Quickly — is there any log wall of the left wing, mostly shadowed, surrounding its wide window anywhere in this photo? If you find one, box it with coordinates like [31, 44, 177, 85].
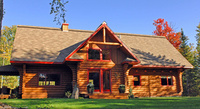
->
[16, 65, 72, 99]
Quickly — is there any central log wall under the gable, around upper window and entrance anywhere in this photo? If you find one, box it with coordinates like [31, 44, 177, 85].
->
[77, 44, 126, 94]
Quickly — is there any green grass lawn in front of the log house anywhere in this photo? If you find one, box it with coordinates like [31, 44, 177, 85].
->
[0, 97, 200, 109]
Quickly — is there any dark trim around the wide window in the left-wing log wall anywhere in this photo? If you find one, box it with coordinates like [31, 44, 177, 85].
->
[37, 72, 62, 87]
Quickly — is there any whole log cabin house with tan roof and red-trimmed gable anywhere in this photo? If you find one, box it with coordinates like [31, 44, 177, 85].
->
[4, 22, 193, 99]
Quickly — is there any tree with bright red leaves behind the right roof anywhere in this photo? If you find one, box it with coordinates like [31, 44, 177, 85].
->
[153, 18, 181, 49]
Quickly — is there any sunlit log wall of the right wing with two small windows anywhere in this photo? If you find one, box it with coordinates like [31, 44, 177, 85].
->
[128, 69, 181, 97]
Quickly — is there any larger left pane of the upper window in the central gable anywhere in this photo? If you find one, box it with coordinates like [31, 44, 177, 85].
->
[88, 49, 100, 60]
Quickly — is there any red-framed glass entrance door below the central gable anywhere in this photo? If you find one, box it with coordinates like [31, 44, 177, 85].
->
[88, 69, 111, 93]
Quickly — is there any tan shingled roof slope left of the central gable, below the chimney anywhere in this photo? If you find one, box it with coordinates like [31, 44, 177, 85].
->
[11, 25, 93, 63]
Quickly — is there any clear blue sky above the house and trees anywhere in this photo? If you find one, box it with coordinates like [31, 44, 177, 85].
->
[3, 0, 200, 44]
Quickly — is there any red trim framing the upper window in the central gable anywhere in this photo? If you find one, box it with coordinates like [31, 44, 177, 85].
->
[87, 47, 111, 62]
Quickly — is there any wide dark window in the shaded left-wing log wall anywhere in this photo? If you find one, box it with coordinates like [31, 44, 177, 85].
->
[39, 73, 60, 86]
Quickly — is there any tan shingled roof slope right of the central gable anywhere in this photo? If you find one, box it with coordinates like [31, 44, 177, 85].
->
[117, 33, 193, 68]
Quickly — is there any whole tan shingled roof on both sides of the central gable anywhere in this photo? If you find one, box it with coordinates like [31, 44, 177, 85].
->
[11, 25, 193, 68]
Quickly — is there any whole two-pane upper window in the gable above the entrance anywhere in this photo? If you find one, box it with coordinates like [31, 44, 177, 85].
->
[88, 49, 110, 60]
